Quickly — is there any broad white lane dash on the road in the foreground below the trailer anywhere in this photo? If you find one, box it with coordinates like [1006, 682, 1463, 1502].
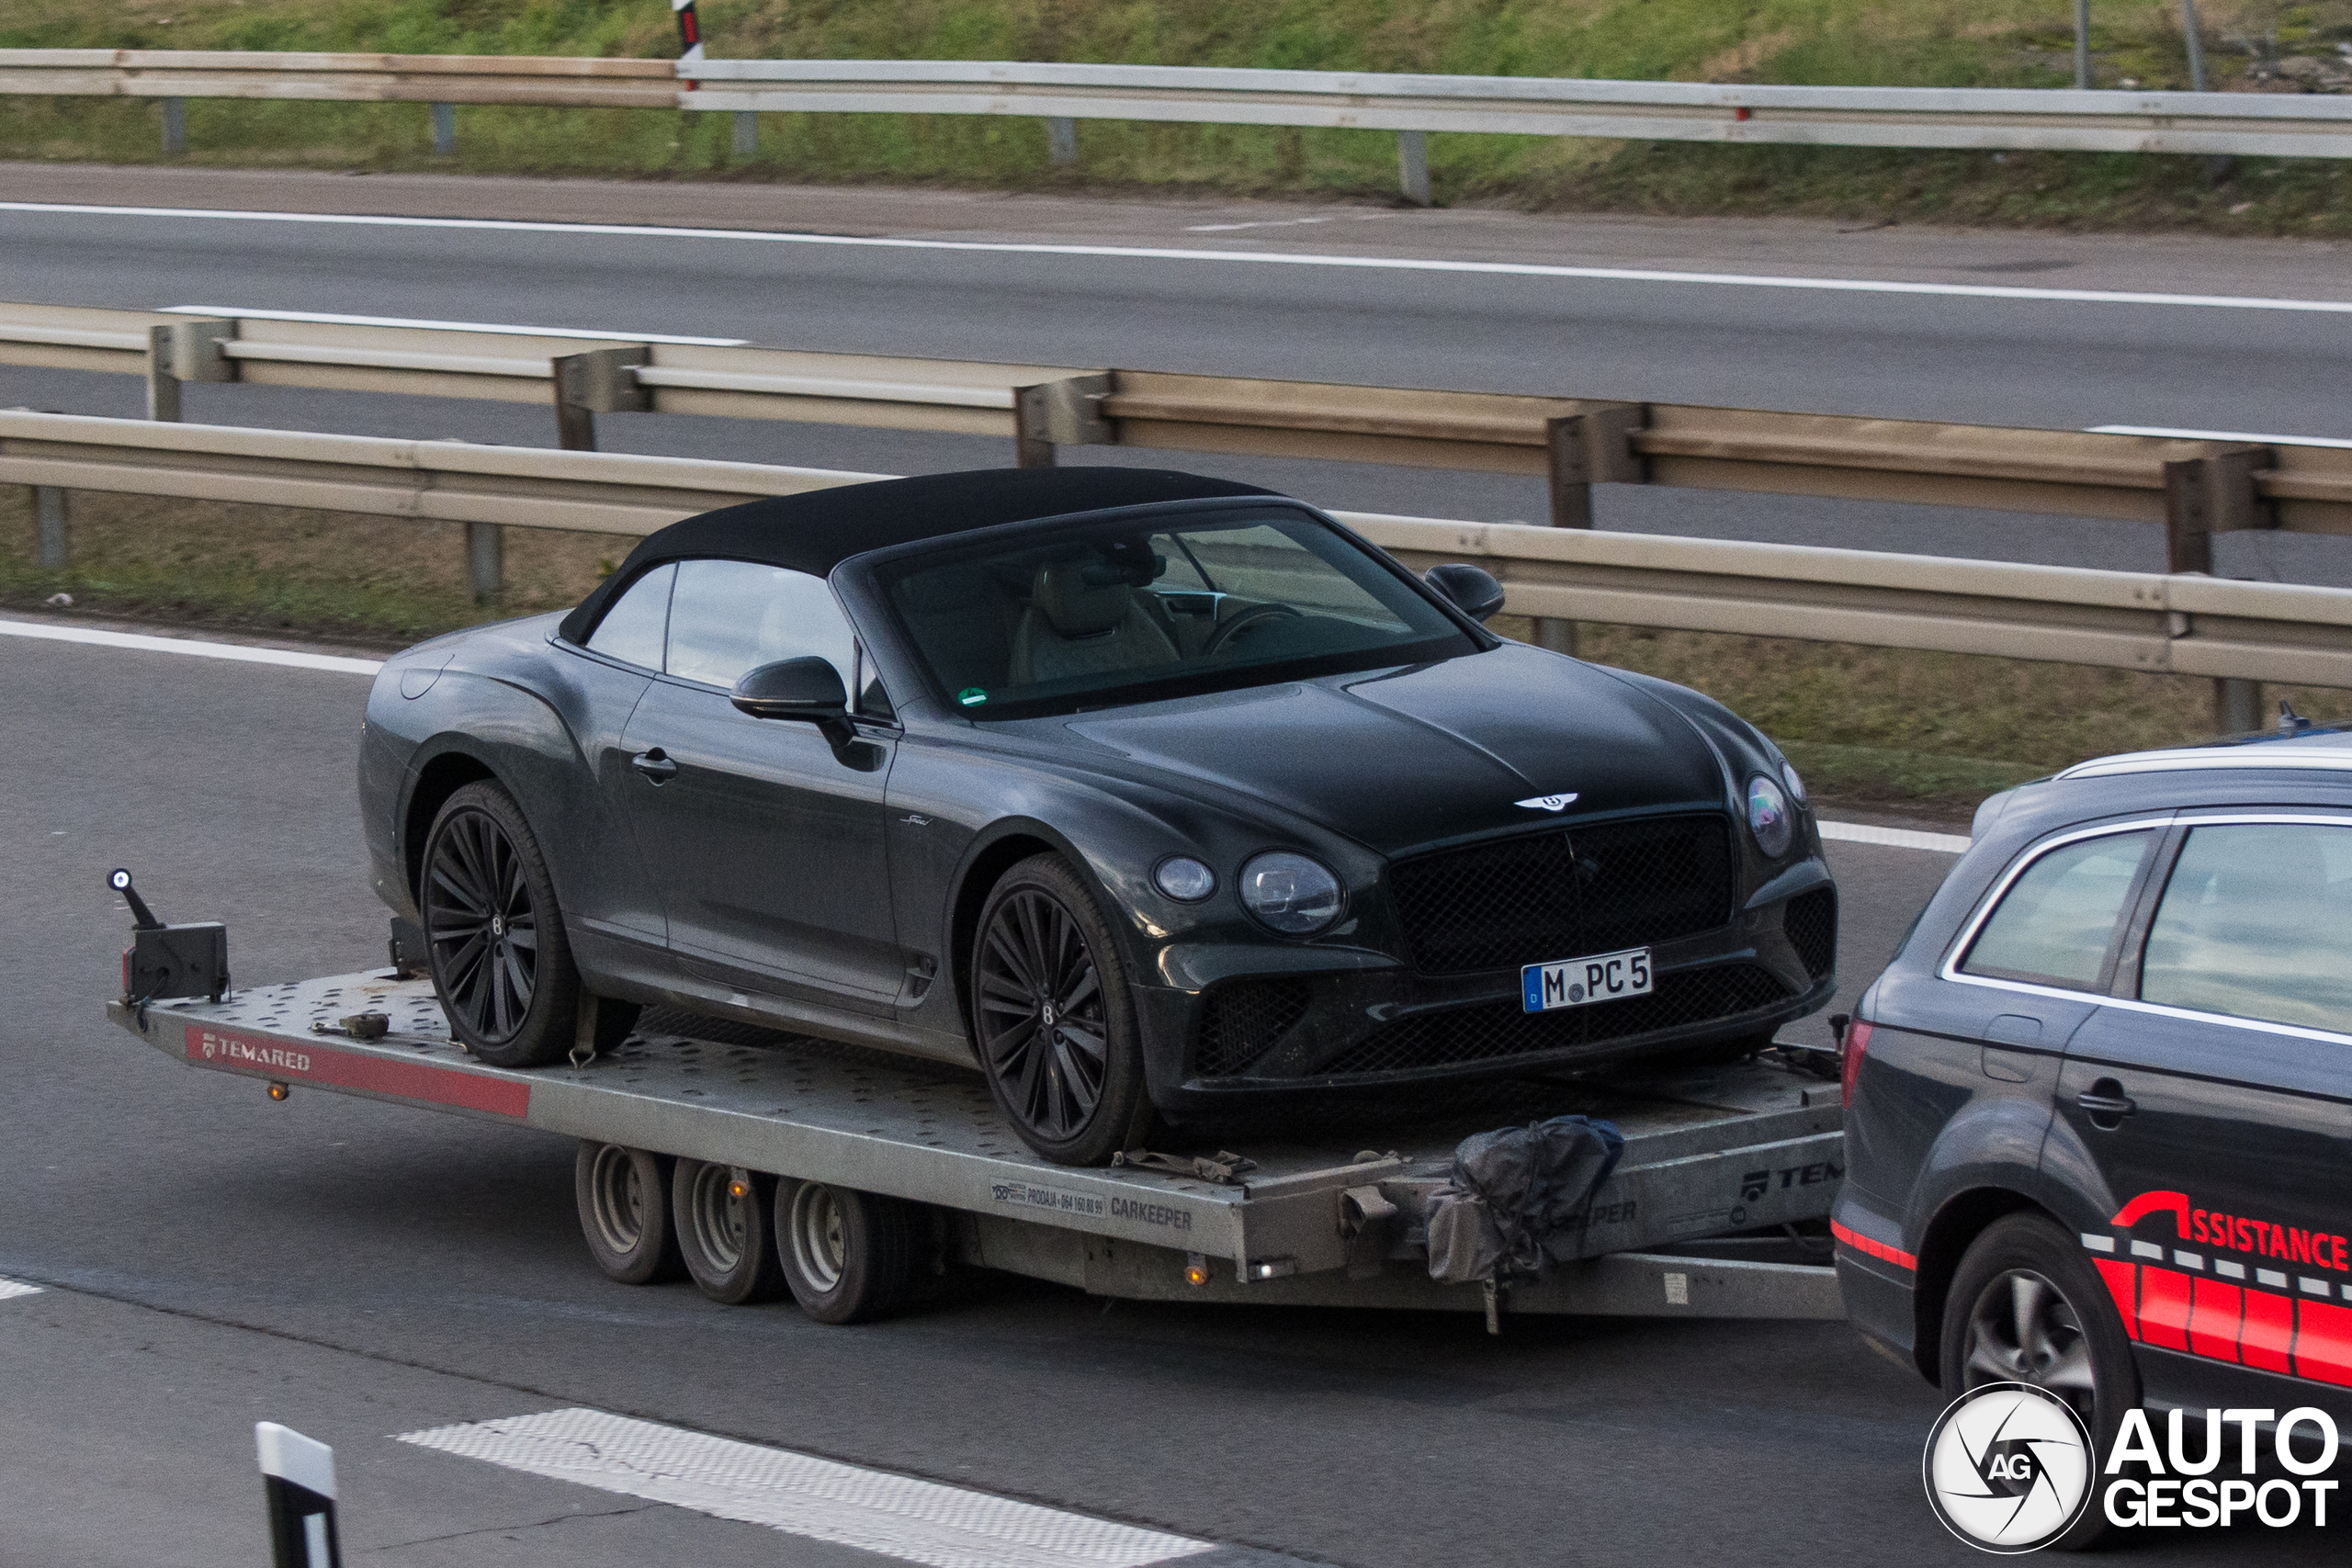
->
[398, 1411, 1214, 1568]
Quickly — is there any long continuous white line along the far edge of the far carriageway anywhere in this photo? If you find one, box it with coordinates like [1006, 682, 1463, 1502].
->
[0, 202, 2352, 315]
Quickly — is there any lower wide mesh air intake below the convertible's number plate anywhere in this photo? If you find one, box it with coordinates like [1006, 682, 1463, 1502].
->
[1317, 964, 1788, 1075]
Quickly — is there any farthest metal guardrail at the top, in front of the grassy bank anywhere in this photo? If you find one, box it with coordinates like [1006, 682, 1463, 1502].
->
[14, 50, 2352, 205]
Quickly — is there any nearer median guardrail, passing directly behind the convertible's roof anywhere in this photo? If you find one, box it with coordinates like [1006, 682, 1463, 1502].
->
[14, 412, 2352, 686]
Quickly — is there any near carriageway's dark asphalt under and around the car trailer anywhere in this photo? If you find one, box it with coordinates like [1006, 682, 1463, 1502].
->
[0, 639, 2338, 1568]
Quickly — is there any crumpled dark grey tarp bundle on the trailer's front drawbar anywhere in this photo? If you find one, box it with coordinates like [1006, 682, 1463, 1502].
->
[1425, 1117, 1625, 1283]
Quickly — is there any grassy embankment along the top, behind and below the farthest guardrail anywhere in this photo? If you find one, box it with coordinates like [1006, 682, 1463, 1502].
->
[0, 0, 2352, 235]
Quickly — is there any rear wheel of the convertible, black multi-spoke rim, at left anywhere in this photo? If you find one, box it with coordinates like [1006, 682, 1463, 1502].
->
[416, 781, 581, 1067]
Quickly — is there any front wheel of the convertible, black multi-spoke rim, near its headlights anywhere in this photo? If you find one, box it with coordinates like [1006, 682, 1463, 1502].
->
[971, 853, 1155, 1166]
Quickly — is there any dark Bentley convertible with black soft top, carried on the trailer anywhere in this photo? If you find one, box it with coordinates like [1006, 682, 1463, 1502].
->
[360, 468, 1837, 1164]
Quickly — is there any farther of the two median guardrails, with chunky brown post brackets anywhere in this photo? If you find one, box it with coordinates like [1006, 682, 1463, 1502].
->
[0, 303, 2352, 571]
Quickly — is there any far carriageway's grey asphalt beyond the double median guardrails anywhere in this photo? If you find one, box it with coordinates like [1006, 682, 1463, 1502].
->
[14, 164, 2352, 583]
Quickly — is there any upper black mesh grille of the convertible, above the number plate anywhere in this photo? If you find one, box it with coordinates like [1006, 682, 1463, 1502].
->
[1387, 813, 1731, 976]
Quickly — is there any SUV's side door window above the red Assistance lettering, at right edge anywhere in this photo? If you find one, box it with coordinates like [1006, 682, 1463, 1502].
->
[2141, 823, 2352, 1034]
